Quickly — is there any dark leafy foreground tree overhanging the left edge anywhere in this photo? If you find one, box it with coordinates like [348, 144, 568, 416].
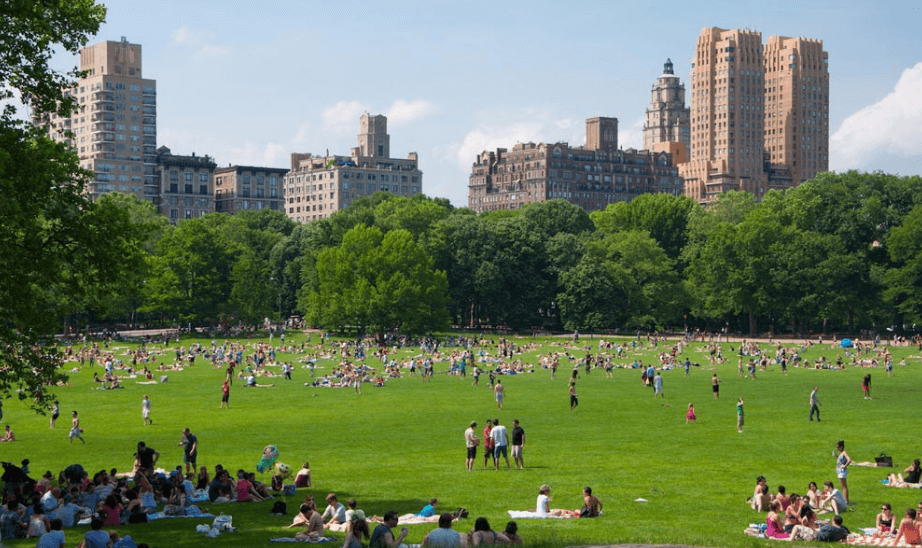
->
[0, 0, 130, 410]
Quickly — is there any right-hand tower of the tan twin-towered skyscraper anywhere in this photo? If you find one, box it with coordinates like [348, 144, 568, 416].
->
[764, 36, 829, 187]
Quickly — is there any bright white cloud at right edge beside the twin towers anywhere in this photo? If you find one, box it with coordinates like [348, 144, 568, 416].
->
[829, 63, 922, 171]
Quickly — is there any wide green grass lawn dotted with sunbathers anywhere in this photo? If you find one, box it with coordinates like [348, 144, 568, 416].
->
[0, 334, 922, 548]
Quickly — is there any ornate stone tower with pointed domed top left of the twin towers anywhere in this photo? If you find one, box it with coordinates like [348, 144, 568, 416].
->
[643, 59, 691, 164]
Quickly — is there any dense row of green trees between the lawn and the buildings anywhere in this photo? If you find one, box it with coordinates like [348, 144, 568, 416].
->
[94, 172, 922, 340]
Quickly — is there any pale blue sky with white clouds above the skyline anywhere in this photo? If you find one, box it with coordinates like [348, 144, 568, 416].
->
[41, 0, 922, 207]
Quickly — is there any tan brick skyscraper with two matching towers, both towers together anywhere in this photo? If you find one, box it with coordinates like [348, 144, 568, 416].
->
[679, 27, 829, 204]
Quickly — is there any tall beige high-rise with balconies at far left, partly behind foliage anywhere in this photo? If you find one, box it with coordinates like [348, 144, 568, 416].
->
[40, 38, 160, 202]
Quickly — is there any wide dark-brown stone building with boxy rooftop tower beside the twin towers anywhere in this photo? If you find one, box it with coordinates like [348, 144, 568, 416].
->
[468, 117, 683, 213]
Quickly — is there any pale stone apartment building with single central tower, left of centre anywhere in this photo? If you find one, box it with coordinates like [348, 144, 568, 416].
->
[284, 114, 423, 223]
